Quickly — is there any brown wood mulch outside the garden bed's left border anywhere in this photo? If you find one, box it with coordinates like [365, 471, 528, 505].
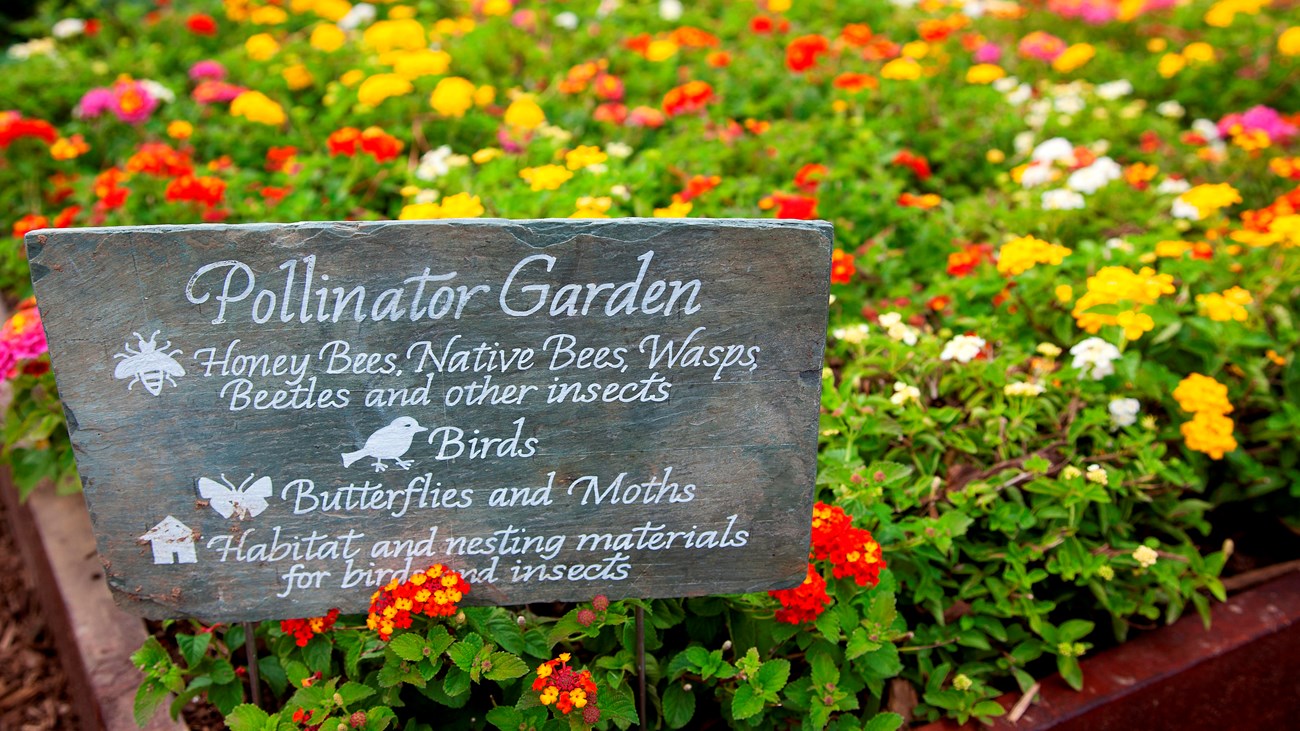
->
[0, 491, 79, 731]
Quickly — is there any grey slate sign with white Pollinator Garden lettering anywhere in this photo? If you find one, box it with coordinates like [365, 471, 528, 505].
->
[27, 219, 832, 622]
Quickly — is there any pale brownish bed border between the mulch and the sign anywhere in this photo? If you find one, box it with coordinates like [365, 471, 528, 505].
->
[0, 468, 189, 731]
